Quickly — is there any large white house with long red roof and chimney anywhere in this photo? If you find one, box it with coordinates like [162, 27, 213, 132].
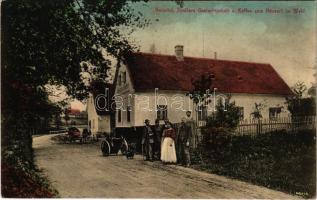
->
[114, 45, 292, 128]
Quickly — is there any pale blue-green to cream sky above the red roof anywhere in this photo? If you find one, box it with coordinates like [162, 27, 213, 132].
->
[72, 1, 317, 109]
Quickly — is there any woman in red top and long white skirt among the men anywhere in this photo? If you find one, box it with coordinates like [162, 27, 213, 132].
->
[161, 123, 177, 163]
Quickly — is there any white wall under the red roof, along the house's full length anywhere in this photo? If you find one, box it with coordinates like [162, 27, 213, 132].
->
[116, 91, 289, 127]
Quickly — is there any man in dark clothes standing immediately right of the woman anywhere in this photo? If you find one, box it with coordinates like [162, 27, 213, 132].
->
[176, 118, 192, 167]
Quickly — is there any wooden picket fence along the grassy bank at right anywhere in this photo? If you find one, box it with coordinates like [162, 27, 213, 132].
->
[234, 116, 316, 135]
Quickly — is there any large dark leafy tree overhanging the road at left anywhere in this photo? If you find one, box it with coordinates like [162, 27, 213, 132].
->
[1, 0, 148, 162]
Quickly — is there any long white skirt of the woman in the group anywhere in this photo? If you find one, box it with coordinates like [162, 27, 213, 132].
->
[161, 137, 177, 163]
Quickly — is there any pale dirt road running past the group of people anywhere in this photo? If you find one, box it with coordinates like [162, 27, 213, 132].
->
[33, 135, 297, 199]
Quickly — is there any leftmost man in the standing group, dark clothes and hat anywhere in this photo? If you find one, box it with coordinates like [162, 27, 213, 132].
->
[142, 119, 154, 161]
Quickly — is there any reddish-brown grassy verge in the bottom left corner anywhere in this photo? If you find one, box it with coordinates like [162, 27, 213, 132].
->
[1, 145, 59, 198]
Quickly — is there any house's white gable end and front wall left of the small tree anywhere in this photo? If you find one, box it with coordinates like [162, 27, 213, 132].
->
[115, 61, 193, 127]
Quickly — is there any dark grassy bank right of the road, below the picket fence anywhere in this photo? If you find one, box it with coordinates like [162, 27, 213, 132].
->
[193, 130, 316, 198]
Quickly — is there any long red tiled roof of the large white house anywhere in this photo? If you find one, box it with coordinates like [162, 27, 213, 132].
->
[126, 53, 292, 95]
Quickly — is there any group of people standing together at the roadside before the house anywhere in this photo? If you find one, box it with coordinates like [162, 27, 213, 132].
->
[142, 111, 192, 166]
